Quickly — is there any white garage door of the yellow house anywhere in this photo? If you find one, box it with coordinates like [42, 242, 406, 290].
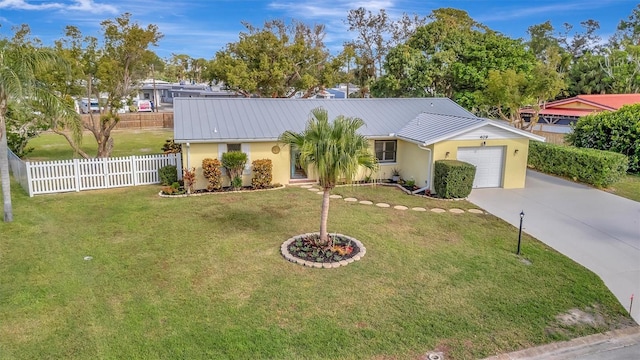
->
[458, 146, 504, 188]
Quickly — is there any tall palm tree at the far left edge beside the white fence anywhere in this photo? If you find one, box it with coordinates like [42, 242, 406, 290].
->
[0, 38, 72, 222]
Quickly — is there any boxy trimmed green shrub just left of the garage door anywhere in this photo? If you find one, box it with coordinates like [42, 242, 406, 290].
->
[433, 160, 476, 199]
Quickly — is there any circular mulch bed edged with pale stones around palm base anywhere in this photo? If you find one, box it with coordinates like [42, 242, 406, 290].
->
[280, 233, 367, 269]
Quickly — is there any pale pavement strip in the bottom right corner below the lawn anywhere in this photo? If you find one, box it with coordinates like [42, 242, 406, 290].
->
[485, 326, 640, 360]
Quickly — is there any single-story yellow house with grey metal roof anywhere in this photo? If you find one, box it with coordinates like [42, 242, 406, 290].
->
[174, 98, 544, 189]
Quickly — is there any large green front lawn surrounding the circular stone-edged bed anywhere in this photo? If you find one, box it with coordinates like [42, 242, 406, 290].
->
[0, 183, 630, 359]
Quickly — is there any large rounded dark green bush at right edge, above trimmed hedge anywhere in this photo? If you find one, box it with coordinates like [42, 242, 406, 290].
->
[566, 104, 640, 173]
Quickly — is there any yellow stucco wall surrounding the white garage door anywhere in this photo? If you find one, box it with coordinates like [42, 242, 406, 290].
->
[433, 138, 529, 189]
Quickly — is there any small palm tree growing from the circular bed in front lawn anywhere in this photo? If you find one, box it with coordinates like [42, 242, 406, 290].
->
[280, 108, 378, 244]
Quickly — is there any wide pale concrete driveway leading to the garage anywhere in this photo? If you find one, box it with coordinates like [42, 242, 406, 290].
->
[469, 170, 640, 323]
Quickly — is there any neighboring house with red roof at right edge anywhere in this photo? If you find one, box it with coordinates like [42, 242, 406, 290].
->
[520, 94, 640, 133]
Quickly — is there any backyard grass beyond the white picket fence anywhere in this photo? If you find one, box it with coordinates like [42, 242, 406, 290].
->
[27, 129, 173, 161]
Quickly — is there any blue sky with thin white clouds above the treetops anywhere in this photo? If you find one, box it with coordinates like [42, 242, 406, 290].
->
[0, 0, 638, 59]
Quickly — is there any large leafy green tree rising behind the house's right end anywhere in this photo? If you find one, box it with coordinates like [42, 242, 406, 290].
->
[372, 8, 535, 110]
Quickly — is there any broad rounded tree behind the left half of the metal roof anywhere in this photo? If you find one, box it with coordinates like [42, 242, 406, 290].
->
[210, 20, 339, 97]
